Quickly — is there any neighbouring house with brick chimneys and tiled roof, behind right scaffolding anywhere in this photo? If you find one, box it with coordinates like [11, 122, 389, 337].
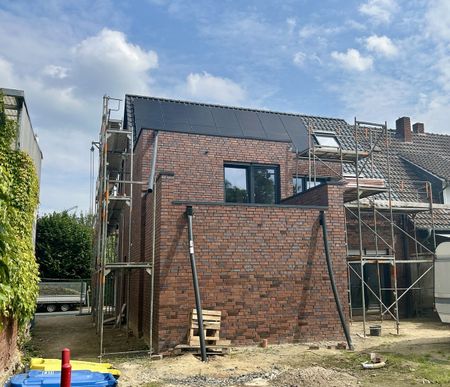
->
[314, 117, 450, 322]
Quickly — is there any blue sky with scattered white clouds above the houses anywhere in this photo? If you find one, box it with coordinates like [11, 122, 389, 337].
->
[0, 0, 450, 214]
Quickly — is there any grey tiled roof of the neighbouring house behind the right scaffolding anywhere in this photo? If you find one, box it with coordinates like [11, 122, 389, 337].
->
[330, 125, 450, 230]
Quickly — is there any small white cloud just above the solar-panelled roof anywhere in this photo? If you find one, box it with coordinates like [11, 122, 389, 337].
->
[181, 72, 246, 104]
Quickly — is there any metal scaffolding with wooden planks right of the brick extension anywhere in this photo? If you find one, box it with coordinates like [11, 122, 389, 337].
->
[298, 118, 436, 336]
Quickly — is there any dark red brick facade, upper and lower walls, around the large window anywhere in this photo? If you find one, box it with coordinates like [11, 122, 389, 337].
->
[124, 130, 348, 351]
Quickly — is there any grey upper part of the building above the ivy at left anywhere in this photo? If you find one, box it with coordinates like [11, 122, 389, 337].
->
[0, 88, 42, 181]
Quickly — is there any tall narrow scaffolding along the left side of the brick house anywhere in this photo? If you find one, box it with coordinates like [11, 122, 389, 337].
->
[91, 96, 153, 359]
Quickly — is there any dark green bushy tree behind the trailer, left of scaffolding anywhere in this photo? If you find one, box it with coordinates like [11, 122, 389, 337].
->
[36, 211, 93, 279]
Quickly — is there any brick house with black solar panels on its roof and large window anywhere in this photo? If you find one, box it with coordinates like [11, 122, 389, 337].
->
[121, 96, 356, 351]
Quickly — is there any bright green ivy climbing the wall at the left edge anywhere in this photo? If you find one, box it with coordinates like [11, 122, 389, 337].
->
[0, 94, 39, 326]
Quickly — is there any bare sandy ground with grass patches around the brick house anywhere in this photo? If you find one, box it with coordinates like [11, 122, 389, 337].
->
[31, 316, 450, 387]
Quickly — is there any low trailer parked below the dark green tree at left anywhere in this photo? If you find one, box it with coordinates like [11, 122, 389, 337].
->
[37, 281, 87, 313]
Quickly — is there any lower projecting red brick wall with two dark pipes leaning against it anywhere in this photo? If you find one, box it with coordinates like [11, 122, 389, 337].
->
[144, 177, 347, 350]
